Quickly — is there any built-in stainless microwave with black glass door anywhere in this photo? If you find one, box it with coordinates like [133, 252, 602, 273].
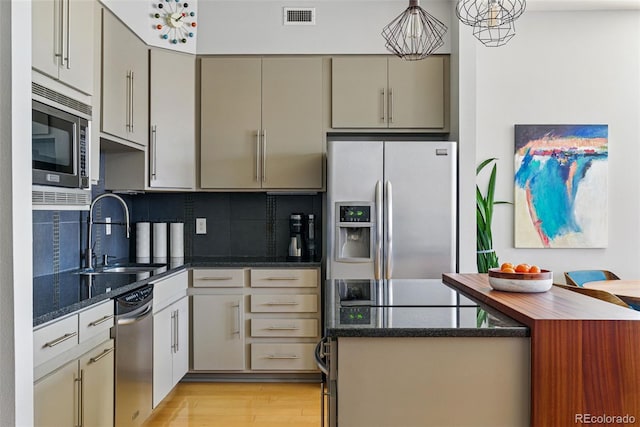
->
[31, 100, 90, 189]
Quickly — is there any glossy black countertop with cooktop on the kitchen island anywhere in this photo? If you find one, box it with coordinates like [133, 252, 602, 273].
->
[324, 279, 530, 338]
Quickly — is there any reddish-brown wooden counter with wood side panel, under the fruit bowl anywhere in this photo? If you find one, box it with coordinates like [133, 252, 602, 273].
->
[442, 273, 640, 427]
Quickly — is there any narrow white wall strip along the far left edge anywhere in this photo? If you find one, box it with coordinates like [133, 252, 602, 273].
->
[0, 0, 33, 426]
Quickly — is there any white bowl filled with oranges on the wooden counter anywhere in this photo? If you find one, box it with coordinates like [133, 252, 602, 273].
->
[489, 262, 553, 292]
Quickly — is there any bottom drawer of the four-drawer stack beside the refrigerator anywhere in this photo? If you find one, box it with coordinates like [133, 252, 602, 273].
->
[251, 343, 317, 371]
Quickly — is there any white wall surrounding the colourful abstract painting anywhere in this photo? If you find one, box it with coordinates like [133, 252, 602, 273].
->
[468, 11, 640, 281]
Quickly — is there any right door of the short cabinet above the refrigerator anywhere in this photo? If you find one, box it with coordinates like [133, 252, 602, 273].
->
[388, 56, 445, 128]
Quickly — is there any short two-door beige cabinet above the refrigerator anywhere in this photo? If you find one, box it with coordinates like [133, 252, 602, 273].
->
[331, 56, 449, 131]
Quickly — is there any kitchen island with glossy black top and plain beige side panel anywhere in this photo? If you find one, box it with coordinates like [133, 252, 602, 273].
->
[318, 279, 530, 427]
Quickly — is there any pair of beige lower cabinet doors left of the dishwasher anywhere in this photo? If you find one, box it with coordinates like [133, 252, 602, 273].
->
[34, 340, 114, 427]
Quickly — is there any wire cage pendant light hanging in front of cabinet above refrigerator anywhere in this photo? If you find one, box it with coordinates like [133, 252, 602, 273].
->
[382, 0, 447, 61]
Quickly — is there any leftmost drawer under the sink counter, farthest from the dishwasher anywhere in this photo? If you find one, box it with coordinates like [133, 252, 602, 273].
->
[33, 314, 78, 366]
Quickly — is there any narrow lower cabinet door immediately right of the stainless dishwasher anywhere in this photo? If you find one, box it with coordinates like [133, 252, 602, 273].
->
[153, 306, 175, 408]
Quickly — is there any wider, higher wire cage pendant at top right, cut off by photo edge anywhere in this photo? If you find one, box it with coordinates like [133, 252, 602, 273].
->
[456, 0, 527, 27]
